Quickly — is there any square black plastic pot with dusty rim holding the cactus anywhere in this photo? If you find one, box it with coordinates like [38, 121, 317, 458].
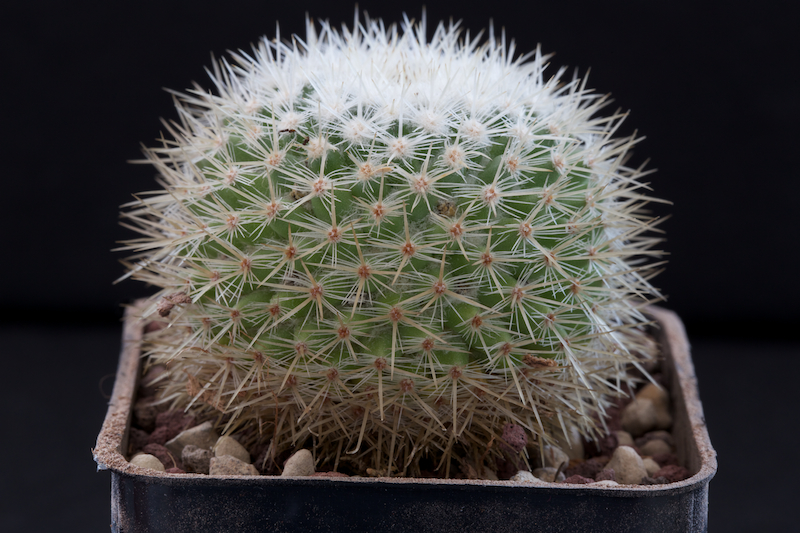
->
[94, 308, 717, 533]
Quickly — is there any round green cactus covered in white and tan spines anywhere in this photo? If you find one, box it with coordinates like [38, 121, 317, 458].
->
[123, 14, 660, 475]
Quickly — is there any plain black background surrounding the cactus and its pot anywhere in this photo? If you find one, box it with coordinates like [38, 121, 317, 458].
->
[0, 0, 800, 532]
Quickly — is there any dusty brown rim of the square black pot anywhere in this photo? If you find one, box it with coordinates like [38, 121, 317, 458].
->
[92, 301, 717, 497]
